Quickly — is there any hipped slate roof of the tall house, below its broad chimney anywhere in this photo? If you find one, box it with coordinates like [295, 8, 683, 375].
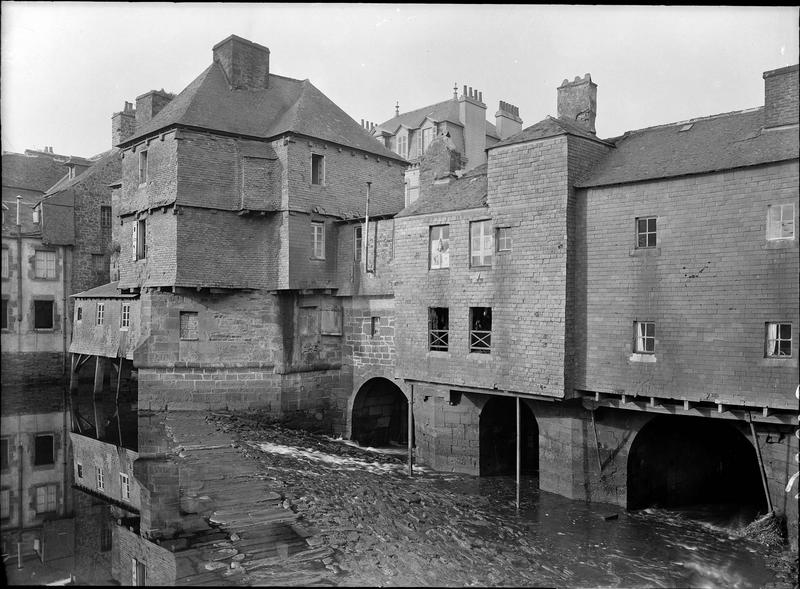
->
[120, 63, 401, 160]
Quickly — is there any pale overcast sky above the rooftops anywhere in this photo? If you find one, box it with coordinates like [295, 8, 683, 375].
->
[0, 2, 799, 157]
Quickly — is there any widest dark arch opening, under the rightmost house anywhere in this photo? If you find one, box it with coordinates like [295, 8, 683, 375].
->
[627, 415, 766, 512]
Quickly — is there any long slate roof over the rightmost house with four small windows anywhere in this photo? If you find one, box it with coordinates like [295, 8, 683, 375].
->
[577, 108, 798, 187]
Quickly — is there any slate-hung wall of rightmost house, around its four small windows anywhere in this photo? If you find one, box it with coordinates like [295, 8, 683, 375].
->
[575, 162, 800, 409]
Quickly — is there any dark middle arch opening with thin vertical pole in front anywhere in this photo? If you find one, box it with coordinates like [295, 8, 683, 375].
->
[479, 396, 539, 476]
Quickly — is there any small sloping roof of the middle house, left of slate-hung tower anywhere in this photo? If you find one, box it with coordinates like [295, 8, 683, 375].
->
[397, 164, 488, 217]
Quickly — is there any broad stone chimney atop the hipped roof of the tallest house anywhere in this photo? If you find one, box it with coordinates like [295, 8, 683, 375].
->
[213, 35, 269, 90]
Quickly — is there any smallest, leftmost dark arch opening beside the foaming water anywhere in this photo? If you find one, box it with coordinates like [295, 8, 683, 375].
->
[348, 376, 413, 446]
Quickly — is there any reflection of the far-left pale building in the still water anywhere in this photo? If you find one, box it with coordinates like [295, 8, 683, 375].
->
[0, 386, 72, 562]
